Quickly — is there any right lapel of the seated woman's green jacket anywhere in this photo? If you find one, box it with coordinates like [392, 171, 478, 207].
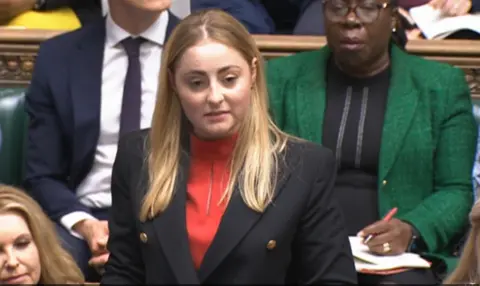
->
[378, 45, 418, 185]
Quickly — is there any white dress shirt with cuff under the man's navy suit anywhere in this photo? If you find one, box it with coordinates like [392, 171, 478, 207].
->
[60, 11, 169, 238]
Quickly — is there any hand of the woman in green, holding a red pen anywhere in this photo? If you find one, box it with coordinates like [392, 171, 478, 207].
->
[358, 218, 413, 255]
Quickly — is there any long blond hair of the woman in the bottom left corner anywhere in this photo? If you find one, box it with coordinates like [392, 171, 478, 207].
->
[0, 185, 84, 284]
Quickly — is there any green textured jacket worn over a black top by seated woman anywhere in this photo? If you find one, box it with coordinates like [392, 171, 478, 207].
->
[267, 45, 477, 271]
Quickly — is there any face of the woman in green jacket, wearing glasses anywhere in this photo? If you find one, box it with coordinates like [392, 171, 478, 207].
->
[324, 0, 393, 67]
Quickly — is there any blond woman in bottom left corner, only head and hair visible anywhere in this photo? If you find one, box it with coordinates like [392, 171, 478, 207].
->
[0, 185, 84, 285]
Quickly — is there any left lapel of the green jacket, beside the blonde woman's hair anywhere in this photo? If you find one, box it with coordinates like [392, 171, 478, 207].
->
[294, 47, 330, 143]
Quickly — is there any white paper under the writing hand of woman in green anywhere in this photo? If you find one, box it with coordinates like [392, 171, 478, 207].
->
[349, 236, 430, 271]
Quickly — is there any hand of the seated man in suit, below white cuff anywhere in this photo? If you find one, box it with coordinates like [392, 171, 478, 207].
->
[73, 219, 109, 269]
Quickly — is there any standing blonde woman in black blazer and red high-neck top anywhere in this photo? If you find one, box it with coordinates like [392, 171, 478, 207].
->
[102, 10, 356, 285]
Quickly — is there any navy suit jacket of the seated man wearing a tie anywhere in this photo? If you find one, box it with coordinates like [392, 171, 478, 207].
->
[25, 13, 179, 220]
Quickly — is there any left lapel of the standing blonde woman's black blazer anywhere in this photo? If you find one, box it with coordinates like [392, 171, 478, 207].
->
[153, 138, 199, 285]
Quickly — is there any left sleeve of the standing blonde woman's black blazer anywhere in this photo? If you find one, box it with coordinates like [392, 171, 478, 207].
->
[101, 135, 145, 285]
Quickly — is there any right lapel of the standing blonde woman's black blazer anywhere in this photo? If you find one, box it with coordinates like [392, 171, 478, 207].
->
[198, 150, 294, 283]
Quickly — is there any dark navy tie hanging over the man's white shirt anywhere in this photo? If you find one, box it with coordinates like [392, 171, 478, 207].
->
[120, 38, 145, 136]
